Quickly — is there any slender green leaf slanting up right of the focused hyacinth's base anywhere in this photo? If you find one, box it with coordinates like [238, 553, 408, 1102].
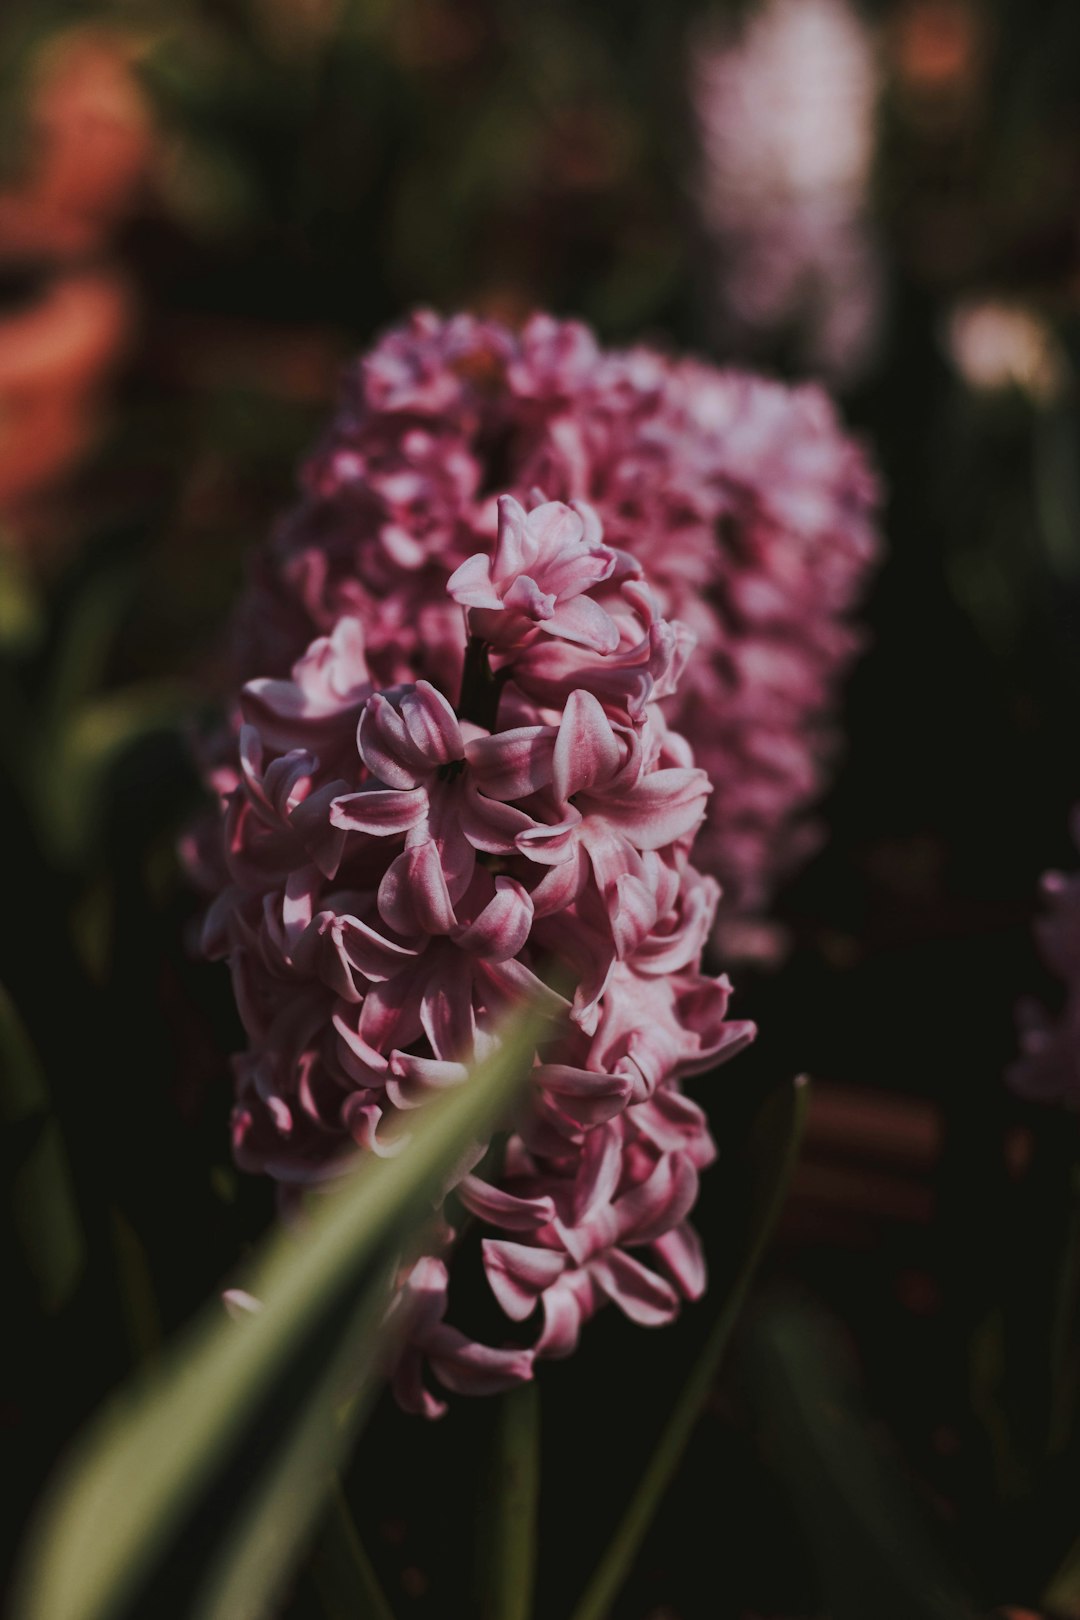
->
[573, 1076, 810, 1620]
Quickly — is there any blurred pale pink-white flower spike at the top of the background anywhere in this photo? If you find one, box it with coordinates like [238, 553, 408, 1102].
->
[690, 0, 882, 381]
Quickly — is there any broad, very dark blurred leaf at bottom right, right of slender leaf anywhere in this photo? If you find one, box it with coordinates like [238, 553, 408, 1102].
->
[745, 1301, 976, 1620]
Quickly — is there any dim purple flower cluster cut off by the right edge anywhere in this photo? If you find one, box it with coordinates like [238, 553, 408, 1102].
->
[1009, 812, 1080, 1108]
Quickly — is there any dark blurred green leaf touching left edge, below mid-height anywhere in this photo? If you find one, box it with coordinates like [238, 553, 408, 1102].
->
[0, 988, 86, 1311]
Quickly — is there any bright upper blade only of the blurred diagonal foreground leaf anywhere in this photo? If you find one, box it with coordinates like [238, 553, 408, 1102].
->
[16, 1013, 538, 1620]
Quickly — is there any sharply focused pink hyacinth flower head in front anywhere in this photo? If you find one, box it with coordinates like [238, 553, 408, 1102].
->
[206, 489, 753, 1414]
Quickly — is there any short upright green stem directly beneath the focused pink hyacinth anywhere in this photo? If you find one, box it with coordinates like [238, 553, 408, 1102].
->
[479, 1383, 541, 1620]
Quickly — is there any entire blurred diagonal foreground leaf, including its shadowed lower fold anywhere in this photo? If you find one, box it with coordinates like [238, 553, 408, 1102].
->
[16, 1013, 538, 1620]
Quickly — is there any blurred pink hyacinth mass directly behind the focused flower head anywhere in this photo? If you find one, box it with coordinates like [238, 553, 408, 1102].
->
[236, 313, 876, 939]
